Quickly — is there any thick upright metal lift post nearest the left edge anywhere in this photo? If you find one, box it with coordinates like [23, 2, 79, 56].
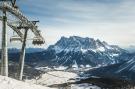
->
[1, 8, 8, 76]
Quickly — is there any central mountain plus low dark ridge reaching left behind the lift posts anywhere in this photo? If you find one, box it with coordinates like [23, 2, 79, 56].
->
[9, 36, 129, 68]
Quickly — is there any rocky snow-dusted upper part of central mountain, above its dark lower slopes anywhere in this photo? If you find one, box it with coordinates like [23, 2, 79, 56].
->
[48, 36, 123, 53]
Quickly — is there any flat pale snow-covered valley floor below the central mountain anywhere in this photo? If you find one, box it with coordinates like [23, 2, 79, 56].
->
[26, 71, 77, 86]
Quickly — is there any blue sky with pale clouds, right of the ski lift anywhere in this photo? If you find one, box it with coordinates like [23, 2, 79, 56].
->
[2, 0, 135, 47]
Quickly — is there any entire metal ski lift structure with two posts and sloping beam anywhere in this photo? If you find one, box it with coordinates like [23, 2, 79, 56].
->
[0, 0, 45, 80]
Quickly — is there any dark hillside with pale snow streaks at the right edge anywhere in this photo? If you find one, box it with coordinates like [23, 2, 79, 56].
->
[81, 53, 135, 82]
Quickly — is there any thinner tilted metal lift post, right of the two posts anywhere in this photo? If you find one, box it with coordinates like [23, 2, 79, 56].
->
[17, 29, 28, 80]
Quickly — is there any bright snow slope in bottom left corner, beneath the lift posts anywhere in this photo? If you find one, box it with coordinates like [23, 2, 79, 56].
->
[0, 76, 54, 89]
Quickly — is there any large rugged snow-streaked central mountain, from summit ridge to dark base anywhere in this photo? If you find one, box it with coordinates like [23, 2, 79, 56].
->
[47, 36, 127, 66]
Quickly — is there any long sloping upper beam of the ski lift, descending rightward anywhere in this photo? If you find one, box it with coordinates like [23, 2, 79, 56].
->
[0, 3, 45, 45]
